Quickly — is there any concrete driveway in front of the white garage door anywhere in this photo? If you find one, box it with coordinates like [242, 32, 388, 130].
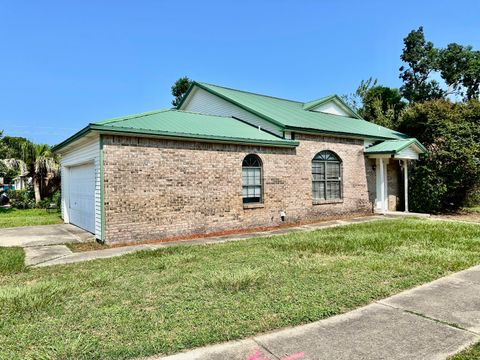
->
[0, 224, 93, 247]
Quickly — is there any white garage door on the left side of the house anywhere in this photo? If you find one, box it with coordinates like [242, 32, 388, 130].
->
[68, 163, 95, 233]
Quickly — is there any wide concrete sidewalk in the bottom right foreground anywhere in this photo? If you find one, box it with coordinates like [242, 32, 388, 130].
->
[148, 266, 480, 360]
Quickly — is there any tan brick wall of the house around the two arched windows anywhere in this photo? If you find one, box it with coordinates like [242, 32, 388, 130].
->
[104, 134, 375, 242]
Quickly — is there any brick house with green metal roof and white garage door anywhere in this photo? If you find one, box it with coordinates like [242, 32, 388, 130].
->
[54, 82, 426, 243]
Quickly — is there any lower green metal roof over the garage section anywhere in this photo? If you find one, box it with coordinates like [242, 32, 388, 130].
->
[53, 109, 298, 151]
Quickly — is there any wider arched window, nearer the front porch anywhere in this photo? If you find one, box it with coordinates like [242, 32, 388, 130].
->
[312, 150, 342, 200]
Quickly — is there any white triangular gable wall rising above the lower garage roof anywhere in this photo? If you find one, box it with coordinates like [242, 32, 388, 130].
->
[179, 86, 283, 137]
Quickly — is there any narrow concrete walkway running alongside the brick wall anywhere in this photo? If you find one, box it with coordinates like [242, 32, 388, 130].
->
[33, 215, 385, 267]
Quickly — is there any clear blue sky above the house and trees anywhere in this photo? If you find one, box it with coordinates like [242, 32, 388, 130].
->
[0, 0, 480, 144]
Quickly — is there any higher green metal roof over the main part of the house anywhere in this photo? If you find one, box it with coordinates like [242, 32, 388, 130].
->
[185, 82, 407, 139]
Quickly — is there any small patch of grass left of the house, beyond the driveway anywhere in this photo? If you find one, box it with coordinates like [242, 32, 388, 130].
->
[0, 208, 63, 228]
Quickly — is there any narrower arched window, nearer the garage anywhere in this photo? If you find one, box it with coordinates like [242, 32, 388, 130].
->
[242, 154, 263, 204]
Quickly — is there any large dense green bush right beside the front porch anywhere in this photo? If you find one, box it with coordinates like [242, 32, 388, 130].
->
[399, 100, 480, 212]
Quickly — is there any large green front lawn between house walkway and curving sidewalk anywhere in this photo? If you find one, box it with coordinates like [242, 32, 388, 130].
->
[0, 219, 480, 359]
